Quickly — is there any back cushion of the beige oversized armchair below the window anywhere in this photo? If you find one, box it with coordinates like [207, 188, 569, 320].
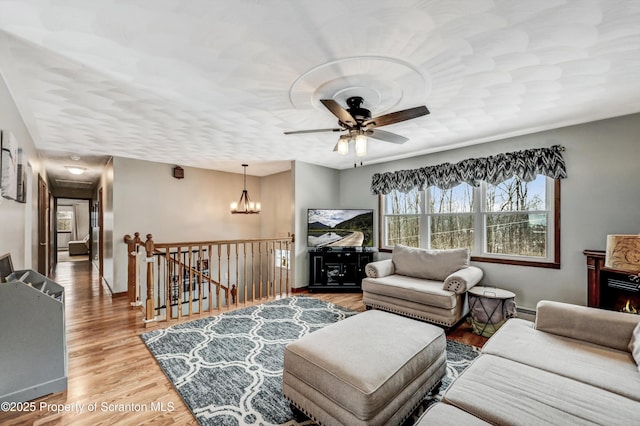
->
[391, 244, 469, 281]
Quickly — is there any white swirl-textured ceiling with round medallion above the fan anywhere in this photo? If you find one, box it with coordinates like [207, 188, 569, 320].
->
[0, 0, 640, 183]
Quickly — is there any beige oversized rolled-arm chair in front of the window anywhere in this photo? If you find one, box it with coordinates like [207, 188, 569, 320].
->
[362, 244, 483, 327]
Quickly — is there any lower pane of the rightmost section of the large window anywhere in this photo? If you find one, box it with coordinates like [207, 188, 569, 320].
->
[486, 213, 547, 257]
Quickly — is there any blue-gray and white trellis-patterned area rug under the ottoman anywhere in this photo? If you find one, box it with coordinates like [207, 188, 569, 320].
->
[141, 296, 477, 425]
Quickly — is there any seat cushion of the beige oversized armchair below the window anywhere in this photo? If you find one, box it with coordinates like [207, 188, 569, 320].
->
[362, 275, 458, 309]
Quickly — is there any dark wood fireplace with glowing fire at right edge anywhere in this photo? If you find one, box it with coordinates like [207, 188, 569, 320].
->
[584, 250, 640, 314]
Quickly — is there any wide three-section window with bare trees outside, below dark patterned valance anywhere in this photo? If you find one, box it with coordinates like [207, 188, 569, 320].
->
[380, 175, 560, 267]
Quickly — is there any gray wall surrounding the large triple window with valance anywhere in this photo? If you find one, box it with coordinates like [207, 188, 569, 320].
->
[339, 114, 640, 309]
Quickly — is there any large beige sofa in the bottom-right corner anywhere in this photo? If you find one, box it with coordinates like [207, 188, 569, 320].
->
[419, 301, 640, 425]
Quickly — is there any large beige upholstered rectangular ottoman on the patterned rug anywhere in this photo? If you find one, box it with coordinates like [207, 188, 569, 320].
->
[282, 310, 446, 426]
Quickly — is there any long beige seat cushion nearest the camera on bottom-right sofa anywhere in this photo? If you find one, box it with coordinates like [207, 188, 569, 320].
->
[442, 352, 638, 425]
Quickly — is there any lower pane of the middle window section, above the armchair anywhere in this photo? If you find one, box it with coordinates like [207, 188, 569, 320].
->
[431, 214, 474, 250]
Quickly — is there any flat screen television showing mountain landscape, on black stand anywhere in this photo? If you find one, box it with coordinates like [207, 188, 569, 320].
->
[307, 209, 373, 247]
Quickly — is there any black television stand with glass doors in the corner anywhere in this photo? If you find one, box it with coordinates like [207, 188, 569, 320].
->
[309, 247, 373, 291]
